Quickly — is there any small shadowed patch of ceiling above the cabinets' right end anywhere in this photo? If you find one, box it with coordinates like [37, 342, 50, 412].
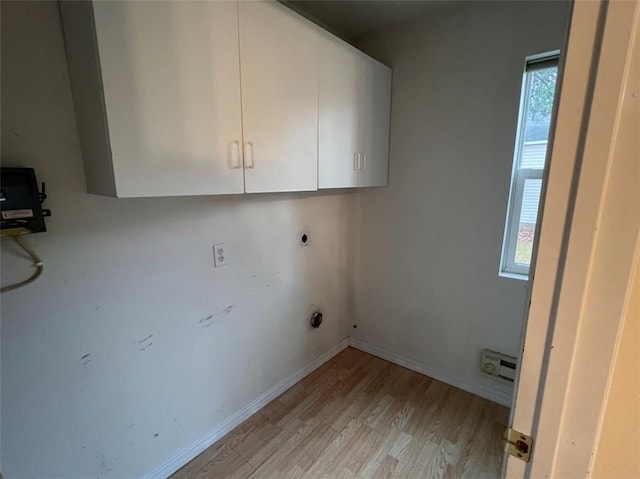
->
[282, 0, 448, 41]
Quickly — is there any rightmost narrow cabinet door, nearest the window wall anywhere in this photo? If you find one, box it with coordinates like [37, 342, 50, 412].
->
[360, 57, 391, 186]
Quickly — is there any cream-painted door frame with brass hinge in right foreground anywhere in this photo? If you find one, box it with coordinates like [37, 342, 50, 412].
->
[504, 1, 640, 479]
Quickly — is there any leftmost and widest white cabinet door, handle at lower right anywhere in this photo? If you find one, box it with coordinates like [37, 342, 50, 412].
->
[89, 1, 243, 197]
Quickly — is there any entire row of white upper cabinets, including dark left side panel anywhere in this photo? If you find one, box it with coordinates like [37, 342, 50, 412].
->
[60, 0, 391, 197]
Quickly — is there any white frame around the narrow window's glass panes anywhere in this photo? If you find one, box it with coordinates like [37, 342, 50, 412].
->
[498, 50, 560, 281]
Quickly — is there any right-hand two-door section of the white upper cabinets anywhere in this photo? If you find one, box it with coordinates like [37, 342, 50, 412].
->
[318, 32, 391, 189]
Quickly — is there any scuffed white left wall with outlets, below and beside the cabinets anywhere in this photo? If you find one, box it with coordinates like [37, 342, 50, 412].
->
[1, 2, 354, 479]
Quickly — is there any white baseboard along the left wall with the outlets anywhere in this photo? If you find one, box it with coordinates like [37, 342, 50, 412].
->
[144, 338, 349, 479]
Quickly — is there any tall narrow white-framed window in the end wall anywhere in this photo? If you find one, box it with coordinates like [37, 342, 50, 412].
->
[500, 53, 558, 279]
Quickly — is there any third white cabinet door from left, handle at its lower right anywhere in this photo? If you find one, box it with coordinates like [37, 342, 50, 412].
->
[318, 34, 363, 188]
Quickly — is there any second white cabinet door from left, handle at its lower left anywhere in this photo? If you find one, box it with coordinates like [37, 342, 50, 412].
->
[239, 1, 318, 193]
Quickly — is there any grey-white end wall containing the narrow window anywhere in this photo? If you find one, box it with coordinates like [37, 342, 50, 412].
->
[351, 2, 568, 403]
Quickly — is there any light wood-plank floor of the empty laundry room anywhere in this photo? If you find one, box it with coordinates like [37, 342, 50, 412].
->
[172, 348, 508, 479]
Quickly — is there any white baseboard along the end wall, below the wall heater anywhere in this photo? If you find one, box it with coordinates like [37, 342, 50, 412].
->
[349, 338, 511, 407]
